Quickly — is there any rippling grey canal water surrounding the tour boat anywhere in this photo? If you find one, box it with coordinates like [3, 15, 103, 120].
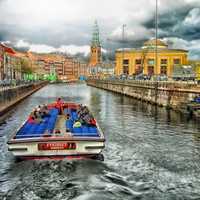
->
[0, 84, 200, 200]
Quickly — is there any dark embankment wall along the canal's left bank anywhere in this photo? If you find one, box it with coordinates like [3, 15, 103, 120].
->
[0, 82, 47, 116]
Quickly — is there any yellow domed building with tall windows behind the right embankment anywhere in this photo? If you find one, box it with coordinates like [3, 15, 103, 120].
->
[115, 39, 188, 77]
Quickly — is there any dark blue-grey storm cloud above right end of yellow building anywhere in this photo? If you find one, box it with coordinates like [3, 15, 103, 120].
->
[143, 5, 200, 59]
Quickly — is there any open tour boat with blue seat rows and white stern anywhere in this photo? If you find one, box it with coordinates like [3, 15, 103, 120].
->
[7, 102, 105, 160]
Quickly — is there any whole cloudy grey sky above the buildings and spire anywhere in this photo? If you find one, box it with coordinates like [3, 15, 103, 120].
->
[0, 0, 200, 58]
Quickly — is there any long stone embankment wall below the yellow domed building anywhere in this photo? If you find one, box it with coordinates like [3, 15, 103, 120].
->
[87, 79, 200, 110]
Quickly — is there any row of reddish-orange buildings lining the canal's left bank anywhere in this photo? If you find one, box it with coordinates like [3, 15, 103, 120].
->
[0, 43, 89, 81]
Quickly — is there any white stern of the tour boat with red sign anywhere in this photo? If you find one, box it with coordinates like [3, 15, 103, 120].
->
[8, 139, 104, 157]
